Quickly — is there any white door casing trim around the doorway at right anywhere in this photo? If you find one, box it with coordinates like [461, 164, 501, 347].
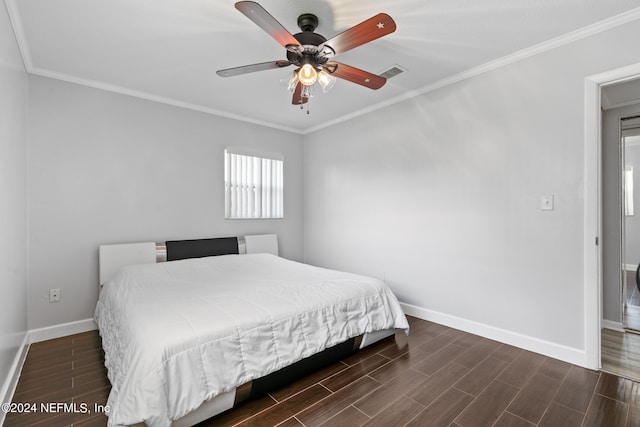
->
[583, 61, 640, 369]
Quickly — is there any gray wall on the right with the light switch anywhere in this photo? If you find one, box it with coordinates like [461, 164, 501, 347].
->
[304, 18, 640, 353]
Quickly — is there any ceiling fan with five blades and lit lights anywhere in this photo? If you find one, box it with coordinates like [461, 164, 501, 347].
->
[216, 1, 396, 108]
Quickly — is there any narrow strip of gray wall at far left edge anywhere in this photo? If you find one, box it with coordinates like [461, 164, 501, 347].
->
[0, 3, 27, 404]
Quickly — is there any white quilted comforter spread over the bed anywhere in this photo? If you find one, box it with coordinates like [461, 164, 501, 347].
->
[95, 254, 408, 426]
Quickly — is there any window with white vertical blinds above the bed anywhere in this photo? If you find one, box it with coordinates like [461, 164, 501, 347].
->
[224, 148, 284, 219]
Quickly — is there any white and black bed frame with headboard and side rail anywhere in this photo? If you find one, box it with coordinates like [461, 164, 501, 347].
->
[99, 234, 395, 427]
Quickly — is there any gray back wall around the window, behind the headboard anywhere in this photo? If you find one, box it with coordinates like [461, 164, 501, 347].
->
[28, 76, 303, 329]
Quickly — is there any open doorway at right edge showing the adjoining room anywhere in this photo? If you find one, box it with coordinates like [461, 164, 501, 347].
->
[599, 79, 640, 379]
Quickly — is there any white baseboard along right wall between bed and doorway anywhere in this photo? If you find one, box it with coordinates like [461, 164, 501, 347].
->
[400, 303, 588, 367]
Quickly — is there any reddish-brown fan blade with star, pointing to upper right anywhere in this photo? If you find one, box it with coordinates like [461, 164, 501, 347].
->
[323, 13, 396, 55]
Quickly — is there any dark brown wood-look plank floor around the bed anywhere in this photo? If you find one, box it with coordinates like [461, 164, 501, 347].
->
[4, 318, 640, 427]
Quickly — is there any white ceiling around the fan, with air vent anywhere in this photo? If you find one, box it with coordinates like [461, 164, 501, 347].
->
[5, 0, 640, 133]
